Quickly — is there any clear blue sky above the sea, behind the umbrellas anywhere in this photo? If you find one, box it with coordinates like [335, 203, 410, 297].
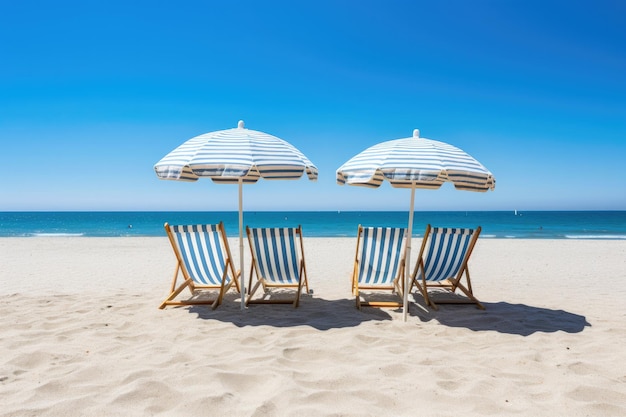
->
[0, 0, 626, 211]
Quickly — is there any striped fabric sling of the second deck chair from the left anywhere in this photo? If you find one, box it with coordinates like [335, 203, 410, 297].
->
[248, 227, 300, 285]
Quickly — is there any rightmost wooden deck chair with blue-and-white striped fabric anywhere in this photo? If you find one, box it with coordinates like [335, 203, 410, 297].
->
[411, 225, 485, 310]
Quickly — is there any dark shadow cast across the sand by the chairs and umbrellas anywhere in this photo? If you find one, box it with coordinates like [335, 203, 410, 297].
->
[182, 293, 591, 336]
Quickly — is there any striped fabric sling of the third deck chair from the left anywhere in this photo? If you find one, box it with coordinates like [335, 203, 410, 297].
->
[358, 227, 406, 285]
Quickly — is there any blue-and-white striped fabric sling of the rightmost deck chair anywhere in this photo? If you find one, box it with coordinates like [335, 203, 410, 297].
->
[417, 227, 474, 282]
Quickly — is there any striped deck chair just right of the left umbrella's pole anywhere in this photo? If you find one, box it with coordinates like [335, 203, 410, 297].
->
[246, 226, 309, 307]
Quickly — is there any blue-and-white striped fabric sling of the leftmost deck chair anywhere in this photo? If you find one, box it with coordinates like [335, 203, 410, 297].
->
[168, 224, 226, 286]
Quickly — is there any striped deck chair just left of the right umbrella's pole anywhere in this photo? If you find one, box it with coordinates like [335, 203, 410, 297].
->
[352, 225, 407, 310]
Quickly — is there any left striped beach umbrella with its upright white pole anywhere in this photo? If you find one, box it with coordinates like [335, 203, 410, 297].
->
[154, 120, 317, 309]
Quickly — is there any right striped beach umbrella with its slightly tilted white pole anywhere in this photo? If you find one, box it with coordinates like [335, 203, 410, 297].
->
[337, 129, 496, 321]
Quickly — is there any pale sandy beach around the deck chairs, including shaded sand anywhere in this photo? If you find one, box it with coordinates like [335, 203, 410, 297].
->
[0, 236, 626, 416]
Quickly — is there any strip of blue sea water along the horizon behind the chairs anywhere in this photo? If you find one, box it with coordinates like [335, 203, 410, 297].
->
[0, 211, 626, 240]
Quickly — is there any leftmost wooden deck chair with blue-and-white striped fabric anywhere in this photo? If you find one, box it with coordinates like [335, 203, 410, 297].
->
[159, 222, 239, 309]
